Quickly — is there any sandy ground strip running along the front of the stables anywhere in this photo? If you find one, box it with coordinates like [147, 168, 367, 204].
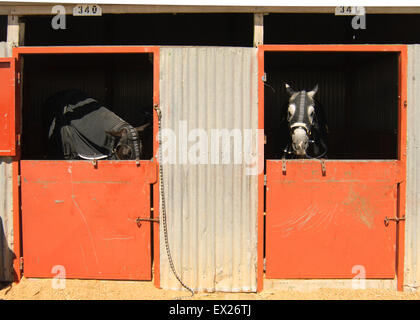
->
[0, 278, 420, 300]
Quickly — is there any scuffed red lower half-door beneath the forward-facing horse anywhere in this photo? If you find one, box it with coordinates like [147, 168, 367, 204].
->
[266, 160, 399, 279]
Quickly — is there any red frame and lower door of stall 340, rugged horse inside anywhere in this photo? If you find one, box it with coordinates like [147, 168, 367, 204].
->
[13, 46, 159, 280]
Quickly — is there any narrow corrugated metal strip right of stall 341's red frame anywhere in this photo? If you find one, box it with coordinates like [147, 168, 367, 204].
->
[404, 45, 420, 289]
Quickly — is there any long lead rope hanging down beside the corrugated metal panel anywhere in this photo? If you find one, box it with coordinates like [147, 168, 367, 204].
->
[153, 104, 194, 297]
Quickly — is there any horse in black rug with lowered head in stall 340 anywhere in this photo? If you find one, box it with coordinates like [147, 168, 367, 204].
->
[44, 90, 149, 160]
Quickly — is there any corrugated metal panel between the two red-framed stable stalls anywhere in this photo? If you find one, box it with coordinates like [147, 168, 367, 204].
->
[160, 47, 258, 292]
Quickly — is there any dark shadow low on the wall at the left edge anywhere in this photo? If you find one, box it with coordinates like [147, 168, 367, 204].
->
[0, 217, 17, 290]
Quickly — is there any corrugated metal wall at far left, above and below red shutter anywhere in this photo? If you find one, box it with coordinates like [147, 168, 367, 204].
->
[0, 42, 14, 281]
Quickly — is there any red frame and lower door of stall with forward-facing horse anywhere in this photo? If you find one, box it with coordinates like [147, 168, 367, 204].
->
[258, 45, 407, 290]
